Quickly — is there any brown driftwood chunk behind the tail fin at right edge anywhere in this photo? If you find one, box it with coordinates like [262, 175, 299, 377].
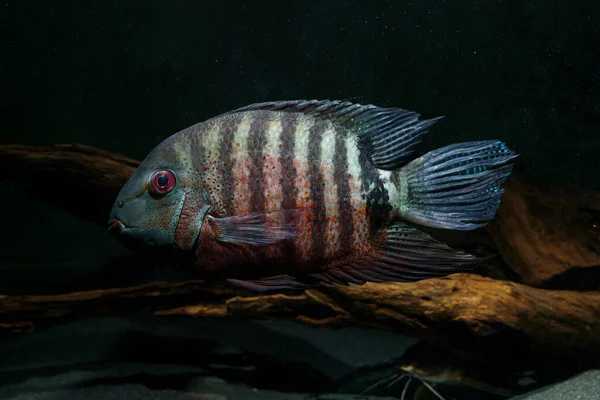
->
[488, 179, 600, 287]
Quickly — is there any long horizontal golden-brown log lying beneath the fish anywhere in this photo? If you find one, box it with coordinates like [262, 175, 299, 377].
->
[0, 274, 600, 357]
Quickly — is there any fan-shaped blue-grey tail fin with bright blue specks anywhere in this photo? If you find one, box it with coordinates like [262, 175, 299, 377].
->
[399, 140, 517, 230]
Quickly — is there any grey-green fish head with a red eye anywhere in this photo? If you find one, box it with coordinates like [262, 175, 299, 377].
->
[108, 135, 210, 252]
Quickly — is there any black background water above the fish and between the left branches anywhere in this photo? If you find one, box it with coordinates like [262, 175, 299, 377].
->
[0, 0, 600, 282]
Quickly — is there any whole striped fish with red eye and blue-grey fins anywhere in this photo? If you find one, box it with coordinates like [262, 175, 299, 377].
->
[108, 100, 518, 291]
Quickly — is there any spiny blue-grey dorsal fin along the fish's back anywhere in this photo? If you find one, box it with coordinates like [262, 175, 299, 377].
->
[226, 100, 443, 170]
